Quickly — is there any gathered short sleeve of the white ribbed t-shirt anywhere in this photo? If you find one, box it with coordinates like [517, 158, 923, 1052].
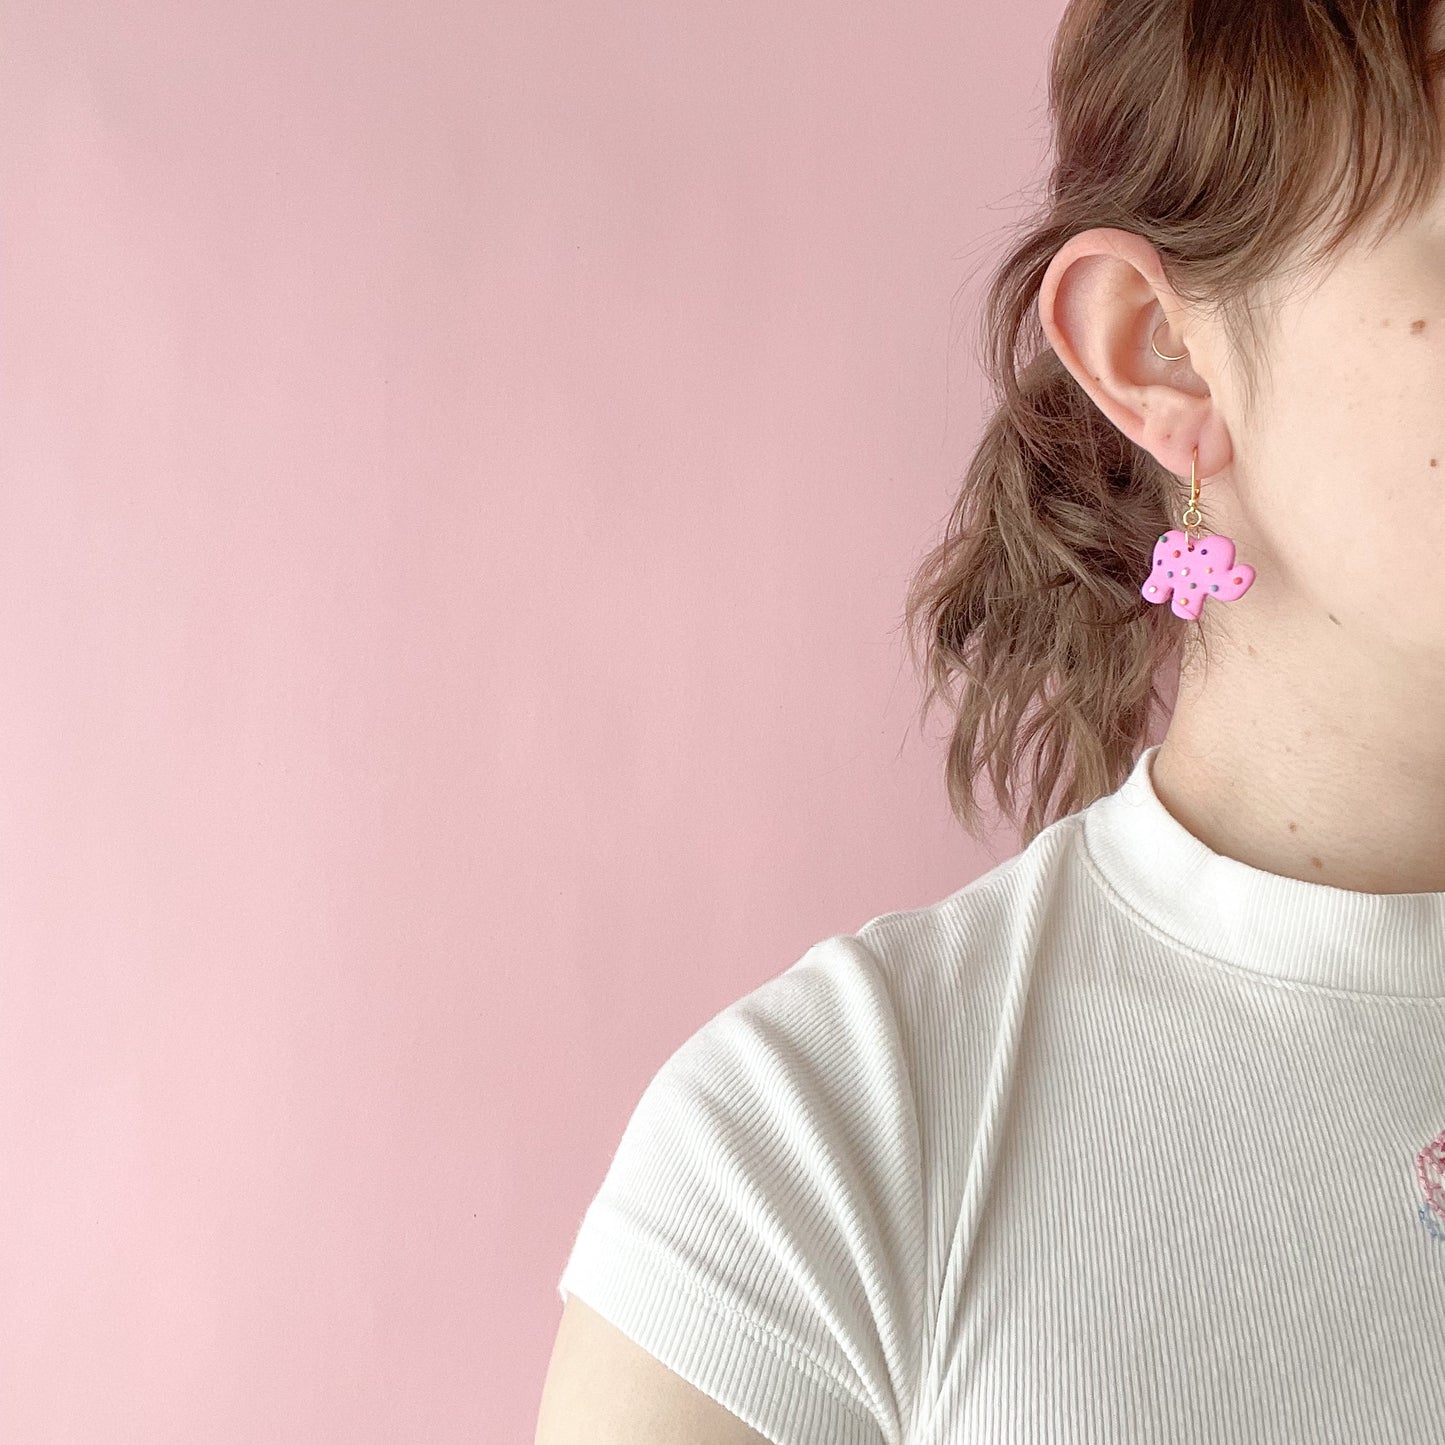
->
[558, 935, 923, 1445]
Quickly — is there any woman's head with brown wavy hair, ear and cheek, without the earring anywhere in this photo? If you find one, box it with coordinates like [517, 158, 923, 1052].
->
[906, 0, 1445, 840]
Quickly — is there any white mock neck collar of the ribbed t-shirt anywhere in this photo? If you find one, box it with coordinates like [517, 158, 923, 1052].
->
[1082, 743, 1445, 998]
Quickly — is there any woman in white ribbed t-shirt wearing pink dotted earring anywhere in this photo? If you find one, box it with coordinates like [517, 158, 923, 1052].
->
[536, 0, 1445, 1445]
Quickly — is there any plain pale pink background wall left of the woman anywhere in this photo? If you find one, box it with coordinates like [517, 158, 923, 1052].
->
[0, 0, 1062, 1445]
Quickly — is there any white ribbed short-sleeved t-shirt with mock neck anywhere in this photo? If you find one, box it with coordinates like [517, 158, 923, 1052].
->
[558, 744, 1445, 1445]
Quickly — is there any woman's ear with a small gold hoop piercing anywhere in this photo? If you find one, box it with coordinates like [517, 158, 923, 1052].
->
[1039, 227, 1234, 477]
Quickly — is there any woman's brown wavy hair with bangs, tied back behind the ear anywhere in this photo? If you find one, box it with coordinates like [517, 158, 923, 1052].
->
[903, 0, 1445, 844]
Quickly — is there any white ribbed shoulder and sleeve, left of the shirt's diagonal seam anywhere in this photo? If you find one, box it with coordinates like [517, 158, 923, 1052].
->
[558, 831, 1086, 1445]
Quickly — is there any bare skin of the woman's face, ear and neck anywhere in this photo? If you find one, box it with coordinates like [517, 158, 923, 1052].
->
[1039, 202, 1445, 893]
